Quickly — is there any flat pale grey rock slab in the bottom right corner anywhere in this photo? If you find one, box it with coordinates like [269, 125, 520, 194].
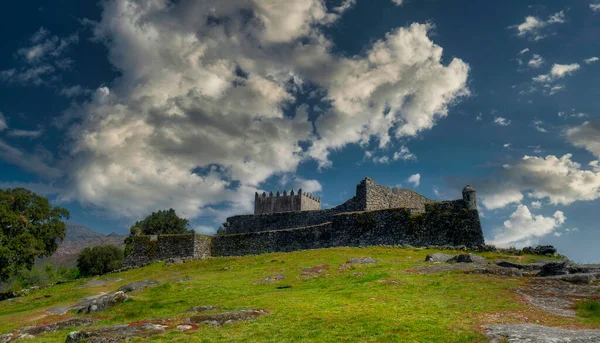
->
[486, 324, 600, 343]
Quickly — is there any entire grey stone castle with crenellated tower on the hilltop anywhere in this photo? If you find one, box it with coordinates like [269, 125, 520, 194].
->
[125, 178, 484, 266]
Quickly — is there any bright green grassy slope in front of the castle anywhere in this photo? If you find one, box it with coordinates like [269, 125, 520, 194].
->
[0, 247, 598, 343]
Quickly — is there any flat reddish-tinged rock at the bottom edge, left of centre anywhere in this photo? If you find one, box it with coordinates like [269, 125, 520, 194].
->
[66, 323, 165, 343]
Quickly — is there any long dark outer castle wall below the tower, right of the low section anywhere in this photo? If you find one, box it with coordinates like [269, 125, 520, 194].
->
[212, 206, 484, 256]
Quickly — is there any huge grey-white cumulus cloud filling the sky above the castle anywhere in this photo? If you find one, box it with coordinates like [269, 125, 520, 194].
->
[56, 0, 469, 226]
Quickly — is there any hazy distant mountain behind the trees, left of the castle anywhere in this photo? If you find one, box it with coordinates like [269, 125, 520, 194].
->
[36, 223, 127, 267]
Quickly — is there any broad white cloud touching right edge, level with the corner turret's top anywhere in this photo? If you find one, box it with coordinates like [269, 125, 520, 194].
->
[479, 154, 600, 209]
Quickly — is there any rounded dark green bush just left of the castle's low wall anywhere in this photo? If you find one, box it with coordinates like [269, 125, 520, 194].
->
[77, 245, 124, 276]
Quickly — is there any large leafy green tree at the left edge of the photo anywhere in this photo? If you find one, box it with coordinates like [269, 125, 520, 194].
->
[0, 188, 69, 281]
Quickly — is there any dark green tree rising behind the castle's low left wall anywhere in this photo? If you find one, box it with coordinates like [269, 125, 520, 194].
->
[130, 208, 194, 235]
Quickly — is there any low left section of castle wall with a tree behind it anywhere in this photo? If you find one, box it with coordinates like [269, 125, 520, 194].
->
[124, 234, 211, 267]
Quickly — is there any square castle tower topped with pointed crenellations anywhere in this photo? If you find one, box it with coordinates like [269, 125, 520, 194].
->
[254, 189, 321, 214]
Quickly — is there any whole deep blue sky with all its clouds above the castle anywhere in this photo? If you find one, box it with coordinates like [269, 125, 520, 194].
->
[0, 0, 600, 262]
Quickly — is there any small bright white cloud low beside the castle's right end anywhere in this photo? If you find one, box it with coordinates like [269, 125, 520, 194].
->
[489, 205, 567, 247]
